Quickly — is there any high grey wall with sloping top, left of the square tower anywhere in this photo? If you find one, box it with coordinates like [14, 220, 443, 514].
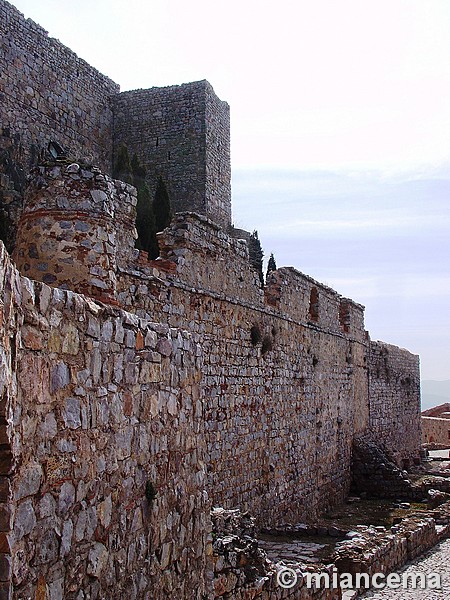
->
[0, 0, 119, 172]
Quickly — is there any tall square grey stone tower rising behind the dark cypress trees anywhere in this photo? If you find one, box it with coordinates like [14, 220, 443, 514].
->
[114, 81, 231, 228]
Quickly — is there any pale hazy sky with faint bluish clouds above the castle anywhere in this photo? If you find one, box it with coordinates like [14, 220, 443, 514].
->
[8, 0, 450, 379]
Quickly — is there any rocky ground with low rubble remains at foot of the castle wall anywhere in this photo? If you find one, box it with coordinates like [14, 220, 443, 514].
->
[213, 459, 450, 600]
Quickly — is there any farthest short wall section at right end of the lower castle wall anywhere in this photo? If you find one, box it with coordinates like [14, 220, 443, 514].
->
[369, 342, 421, 466]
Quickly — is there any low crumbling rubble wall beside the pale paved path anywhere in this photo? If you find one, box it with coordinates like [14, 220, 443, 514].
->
[211, 502, 450, 600]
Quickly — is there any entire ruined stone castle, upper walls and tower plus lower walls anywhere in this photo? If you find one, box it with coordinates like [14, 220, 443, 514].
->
[0, 0, 421, 600]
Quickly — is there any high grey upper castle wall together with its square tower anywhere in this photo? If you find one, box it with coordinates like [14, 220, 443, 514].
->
[0, 0, 231, 251]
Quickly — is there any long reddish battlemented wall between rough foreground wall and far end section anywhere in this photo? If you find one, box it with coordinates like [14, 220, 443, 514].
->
[117, 214, 368, 524]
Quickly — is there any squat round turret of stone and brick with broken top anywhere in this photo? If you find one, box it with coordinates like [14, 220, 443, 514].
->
[13, 163, 137, 303]
